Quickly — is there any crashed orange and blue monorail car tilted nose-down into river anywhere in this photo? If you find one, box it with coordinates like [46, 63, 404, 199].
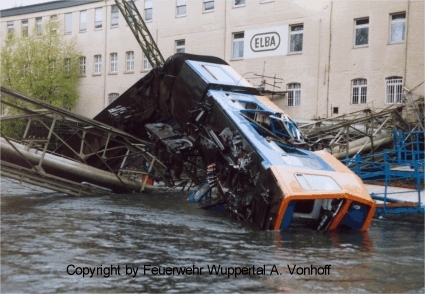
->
[79, 54, 375, 230]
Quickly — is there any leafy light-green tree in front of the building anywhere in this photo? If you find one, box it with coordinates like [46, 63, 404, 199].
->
[0, 20, 80, 109]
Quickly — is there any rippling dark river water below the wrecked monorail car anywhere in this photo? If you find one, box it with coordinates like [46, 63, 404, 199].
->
[1, 179, 425, 293]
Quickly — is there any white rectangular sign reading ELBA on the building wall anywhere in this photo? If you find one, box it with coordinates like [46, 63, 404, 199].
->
[244, 26, 288, 58]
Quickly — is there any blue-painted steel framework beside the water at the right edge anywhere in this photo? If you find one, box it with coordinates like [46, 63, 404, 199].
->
[345, 130, 425, 215]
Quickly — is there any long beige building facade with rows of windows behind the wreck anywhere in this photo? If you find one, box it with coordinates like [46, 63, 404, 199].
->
[0, 0, 424, 120]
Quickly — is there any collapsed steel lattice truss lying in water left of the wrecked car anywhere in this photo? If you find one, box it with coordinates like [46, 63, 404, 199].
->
[1, 87, 205, 195]
